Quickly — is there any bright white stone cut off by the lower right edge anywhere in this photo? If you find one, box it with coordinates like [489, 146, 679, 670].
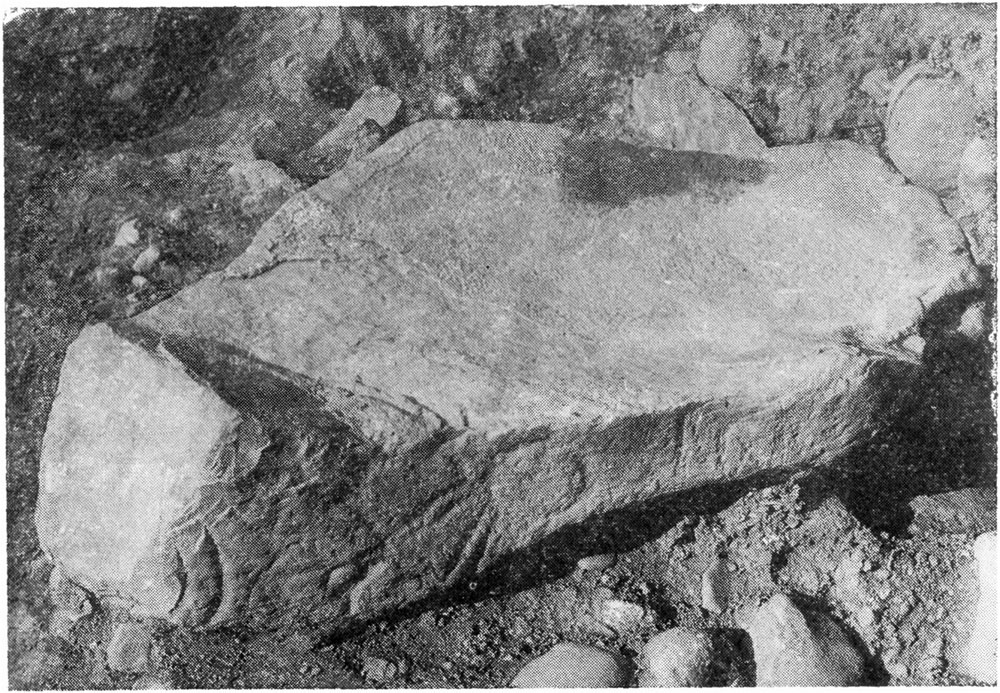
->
[956, 531, 997, 686]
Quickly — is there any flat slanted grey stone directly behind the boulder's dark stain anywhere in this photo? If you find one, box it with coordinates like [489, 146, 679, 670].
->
[630, 73, 765, 158]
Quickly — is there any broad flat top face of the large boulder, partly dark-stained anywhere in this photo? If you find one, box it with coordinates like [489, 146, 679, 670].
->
[152, 121, 977, 430]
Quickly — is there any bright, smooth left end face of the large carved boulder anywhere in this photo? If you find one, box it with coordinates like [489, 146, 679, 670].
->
[37, 325, 239, 609]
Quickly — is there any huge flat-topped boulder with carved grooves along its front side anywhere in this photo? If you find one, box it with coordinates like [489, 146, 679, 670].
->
[36, 121, 980, 630]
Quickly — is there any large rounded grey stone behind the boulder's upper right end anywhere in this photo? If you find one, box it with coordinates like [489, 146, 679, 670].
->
[886, 63, 976, 192]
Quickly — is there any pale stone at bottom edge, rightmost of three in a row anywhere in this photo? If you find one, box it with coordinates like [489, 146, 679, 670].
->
[749, 594, 863, 686]
